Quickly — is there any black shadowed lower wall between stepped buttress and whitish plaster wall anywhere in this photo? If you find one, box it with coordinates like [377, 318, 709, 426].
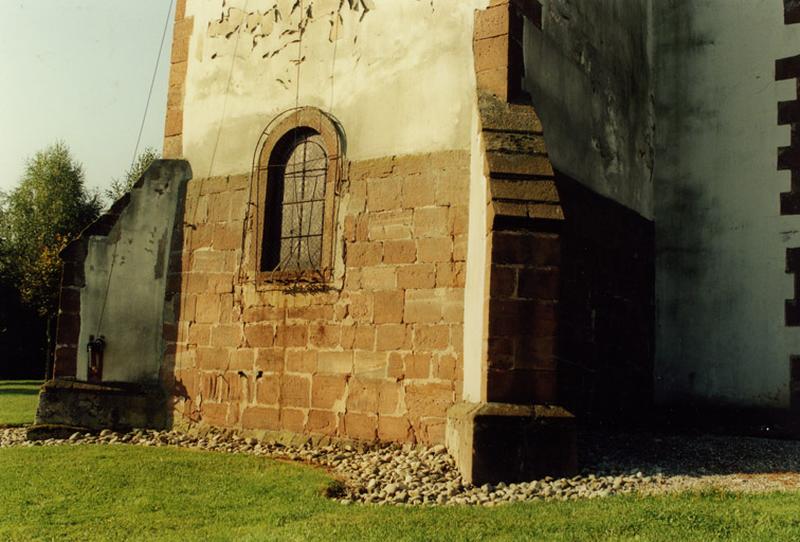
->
[556, 172, 655, 423]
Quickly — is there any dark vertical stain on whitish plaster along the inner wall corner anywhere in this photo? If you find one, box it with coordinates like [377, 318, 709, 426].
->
[653, 0, 746, 394]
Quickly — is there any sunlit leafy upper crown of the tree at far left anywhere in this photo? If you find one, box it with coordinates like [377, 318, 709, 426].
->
[0, 142, 102, 316]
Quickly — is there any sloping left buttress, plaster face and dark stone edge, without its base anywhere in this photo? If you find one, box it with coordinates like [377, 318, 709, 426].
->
[54, 160, 191, 382]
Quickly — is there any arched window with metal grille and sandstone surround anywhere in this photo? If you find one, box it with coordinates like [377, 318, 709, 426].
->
[254, 108, 340, 281]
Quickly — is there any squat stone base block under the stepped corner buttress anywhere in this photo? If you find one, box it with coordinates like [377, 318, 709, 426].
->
[446, 403, 578, 485]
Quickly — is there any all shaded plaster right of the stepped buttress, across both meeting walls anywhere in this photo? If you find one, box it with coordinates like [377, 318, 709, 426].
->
[525, 0, 800, 407]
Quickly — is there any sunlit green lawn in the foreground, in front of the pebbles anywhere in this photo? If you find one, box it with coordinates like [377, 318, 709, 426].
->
[0, 445, 800, 542]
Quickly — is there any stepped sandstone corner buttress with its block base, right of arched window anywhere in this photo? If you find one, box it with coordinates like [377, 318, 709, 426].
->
[447, 0, 577, 484]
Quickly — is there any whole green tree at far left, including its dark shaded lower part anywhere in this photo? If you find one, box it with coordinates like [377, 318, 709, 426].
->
[0, 142, 102, 380]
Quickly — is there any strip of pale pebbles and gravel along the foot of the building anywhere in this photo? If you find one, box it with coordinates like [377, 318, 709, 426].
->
[0, 429, 800, 506]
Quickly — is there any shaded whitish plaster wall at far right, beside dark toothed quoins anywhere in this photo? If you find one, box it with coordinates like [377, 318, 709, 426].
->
[653, 0, 800, 407]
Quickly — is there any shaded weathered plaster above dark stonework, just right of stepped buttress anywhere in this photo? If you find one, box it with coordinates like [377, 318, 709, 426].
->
[523, 0, 655, 219]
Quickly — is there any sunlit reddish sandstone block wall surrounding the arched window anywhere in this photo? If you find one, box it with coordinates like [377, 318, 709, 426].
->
[163, 152, 469, 444]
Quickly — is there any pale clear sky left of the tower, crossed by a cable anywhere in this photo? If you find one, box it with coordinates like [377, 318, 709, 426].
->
[0, 0, 174, 197]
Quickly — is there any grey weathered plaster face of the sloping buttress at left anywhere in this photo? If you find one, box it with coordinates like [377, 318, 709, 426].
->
[77, 161, 191, 382]
